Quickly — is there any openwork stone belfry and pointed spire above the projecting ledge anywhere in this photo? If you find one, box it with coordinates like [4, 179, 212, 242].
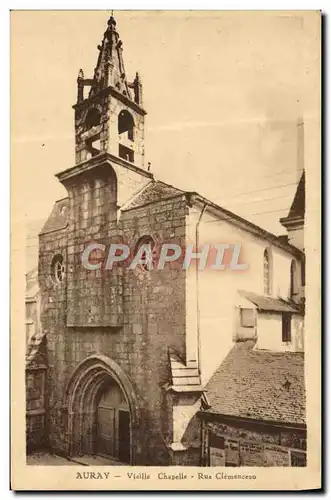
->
[73, 16, 146, 168]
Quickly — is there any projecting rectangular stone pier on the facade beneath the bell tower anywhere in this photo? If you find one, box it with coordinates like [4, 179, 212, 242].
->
[67, 165, 123, 327]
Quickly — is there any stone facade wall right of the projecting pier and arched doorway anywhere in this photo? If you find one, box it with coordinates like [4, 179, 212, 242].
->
[120, 198, 187, 465]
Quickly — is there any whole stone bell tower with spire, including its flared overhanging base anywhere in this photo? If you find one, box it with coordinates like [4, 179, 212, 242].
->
[56, 12, 153, 216]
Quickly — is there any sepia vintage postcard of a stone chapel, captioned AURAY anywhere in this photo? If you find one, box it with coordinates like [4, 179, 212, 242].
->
[11, 10, 322, 490]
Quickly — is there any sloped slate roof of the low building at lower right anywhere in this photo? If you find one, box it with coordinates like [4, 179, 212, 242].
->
[206, 340, 306, 424]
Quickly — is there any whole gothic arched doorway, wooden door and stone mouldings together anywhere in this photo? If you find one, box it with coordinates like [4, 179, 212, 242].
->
[65, 355, 139, 464]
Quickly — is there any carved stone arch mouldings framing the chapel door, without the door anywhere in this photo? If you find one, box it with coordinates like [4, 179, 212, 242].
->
[64, 355, 140, 465]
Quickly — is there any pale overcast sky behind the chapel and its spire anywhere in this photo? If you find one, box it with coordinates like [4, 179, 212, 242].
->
[12, 11, 317, 266]
